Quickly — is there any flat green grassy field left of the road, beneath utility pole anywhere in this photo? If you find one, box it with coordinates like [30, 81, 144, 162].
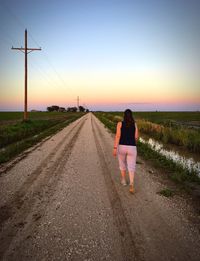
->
[0, 112, 83, 164]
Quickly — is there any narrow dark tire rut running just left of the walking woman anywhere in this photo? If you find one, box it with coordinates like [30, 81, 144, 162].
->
[91, 116, 144, 261]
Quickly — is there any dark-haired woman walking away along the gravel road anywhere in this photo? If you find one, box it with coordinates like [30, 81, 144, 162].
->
[113, 109, 138, 194]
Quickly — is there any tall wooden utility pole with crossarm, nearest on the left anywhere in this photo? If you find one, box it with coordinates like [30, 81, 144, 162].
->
[11, 29, 41, 121]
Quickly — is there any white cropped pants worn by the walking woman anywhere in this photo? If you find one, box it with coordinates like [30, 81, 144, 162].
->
[117, 145, 137, 172]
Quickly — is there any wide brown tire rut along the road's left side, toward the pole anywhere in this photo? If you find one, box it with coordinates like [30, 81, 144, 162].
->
[0, 116, 86, 259]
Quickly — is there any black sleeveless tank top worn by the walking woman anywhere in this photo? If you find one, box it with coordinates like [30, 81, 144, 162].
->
[119, 121, 136, 146]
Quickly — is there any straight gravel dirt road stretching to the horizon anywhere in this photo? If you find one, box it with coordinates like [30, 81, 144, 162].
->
[0, 113, 200, 261]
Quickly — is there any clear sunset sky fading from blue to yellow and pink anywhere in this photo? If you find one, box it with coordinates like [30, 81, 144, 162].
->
[0, 0, 200, 110]
